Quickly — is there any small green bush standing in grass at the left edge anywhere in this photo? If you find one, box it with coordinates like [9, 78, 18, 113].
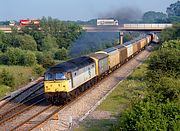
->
[0, 69, 15, 87]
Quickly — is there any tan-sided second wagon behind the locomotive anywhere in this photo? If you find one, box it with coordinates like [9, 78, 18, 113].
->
[96, 47, 120, 69]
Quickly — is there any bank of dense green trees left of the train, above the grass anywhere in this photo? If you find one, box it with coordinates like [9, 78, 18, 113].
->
[0, 17, 82, 68]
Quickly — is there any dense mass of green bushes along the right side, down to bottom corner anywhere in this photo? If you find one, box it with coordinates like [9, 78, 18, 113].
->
[113, 40, 180, 131]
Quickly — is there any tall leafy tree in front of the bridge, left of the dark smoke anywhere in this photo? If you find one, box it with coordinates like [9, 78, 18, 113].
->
[40, 17, 82, 49]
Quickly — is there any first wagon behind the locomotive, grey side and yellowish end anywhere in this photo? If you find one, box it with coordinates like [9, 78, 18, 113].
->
[89, 53, 109, 76]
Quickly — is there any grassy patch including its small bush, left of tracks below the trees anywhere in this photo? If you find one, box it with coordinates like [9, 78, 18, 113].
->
[0, 65, 38, 97]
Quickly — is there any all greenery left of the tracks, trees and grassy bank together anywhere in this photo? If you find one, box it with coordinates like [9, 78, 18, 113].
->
[0, 17, 82, 96]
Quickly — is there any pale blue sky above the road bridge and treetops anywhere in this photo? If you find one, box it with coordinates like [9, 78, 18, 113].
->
[0, 0, 178, 21]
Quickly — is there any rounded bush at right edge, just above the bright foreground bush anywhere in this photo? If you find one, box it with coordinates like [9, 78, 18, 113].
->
[147, 48, 180, 78]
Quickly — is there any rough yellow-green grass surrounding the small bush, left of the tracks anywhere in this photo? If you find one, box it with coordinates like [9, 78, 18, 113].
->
[0, 65, 38, 98]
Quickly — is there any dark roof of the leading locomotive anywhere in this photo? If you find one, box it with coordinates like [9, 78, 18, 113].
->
[47, 56, 94, 72]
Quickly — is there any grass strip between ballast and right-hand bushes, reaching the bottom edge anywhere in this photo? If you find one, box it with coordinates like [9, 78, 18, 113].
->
[77, 62, 148, 131]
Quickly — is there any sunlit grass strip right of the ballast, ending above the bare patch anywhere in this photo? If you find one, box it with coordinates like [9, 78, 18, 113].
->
[96, 64, 147, 112]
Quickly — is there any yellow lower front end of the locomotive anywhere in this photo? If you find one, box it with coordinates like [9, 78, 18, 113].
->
[44, 80, 70, 93]
